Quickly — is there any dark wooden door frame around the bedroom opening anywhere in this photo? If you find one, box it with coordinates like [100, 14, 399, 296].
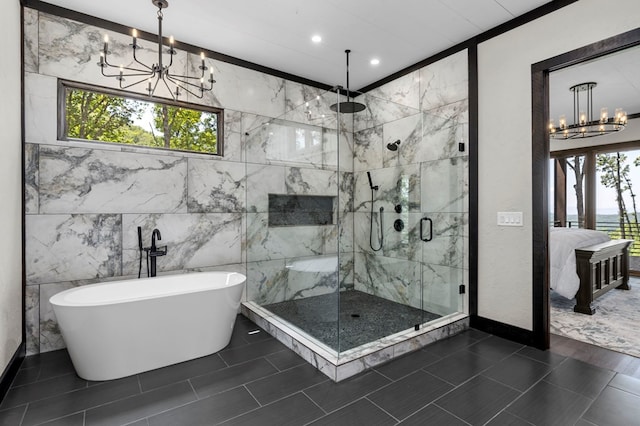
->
[531, 28, 640, 349]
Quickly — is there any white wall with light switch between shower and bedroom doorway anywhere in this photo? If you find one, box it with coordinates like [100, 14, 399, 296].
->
[478, 0, 640, 330]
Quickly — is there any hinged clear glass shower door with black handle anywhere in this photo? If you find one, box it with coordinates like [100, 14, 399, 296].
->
[420, 114, 469, 317]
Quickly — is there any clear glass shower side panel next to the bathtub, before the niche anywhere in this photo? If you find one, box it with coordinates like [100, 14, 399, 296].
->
[243, 91, 343, 350]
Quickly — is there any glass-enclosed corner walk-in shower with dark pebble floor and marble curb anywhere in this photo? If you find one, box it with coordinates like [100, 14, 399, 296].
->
[243, 85, 468, 380]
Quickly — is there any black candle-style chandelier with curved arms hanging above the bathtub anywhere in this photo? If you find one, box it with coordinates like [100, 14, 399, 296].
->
[98, 0, 216, 100]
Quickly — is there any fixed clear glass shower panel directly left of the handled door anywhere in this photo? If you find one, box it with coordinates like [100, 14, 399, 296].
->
[340, 94, 425, 356]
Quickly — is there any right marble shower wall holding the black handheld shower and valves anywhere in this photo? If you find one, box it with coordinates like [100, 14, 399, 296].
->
[354, 51, 469, 315]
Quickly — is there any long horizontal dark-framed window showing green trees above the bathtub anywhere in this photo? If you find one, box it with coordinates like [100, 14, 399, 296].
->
[58, 81, 224, 155]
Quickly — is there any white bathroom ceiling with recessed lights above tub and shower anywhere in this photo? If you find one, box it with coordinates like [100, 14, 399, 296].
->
[46, 0, 549, 89]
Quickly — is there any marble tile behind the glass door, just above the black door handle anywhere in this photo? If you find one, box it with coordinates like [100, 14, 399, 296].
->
[420, 157, 469, 213]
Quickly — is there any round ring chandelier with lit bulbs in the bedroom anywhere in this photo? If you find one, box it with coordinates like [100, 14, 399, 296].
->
[549, 82, 627, 139]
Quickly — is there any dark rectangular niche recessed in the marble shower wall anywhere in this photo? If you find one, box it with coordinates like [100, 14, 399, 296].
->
[269, 194, 335, 226]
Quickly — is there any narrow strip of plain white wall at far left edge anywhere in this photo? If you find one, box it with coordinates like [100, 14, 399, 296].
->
[0, 0, 22, 374]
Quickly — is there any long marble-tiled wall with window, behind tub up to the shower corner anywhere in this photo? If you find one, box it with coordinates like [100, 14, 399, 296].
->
[24, 8, 353, 354]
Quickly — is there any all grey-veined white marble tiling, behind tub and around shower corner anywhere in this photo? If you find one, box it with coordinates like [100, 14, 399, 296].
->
[24, 8, 468, 353]
